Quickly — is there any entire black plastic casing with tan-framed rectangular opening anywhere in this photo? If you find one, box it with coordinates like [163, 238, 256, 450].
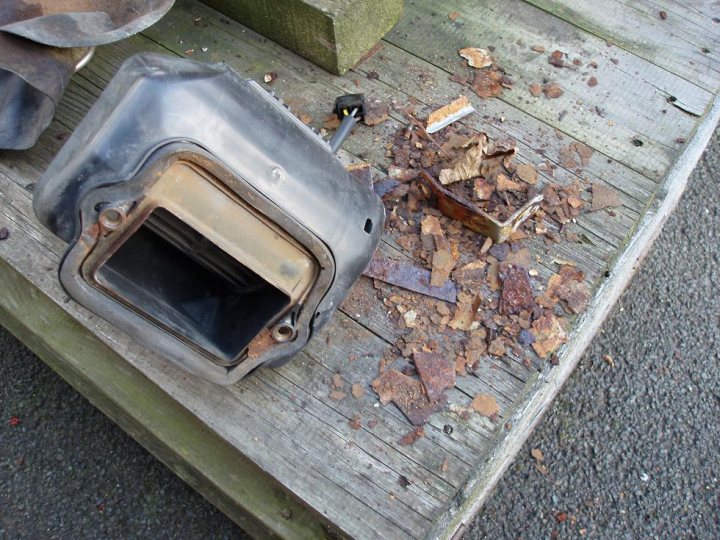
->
[33, 54, 384, 383]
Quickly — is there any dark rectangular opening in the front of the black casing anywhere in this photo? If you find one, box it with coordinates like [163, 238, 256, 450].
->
[95, 208, 290, 365]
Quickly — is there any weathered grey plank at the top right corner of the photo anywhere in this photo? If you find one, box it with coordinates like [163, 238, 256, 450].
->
[527, 0, 720, 92]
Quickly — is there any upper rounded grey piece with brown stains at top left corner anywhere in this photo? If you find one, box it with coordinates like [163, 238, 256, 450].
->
[0, 0, 174, 47]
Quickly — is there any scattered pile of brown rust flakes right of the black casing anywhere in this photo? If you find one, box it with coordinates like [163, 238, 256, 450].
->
[340, 102, 620, 444]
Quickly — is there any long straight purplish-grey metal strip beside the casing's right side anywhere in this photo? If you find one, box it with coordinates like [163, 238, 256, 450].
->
[363, 253, 457, 303]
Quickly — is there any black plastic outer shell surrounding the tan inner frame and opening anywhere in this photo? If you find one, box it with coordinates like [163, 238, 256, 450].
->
[33, 54, 384, 384]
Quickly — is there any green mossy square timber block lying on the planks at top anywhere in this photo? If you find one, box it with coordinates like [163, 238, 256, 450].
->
[203, 0, 403, 75]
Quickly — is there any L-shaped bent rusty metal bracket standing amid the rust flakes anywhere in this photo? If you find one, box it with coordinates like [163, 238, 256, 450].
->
[420, 171, 543, 243]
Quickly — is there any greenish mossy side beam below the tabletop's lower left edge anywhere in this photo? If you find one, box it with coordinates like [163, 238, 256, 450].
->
[0, 259, 342, 539]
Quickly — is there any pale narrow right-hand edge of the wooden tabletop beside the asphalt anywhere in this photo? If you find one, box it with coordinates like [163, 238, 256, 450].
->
[426, 96, 720, 540]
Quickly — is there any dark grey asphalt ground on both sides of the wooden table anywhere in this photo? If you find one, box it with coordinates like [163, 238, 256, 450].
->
[0, 129, 720, 539]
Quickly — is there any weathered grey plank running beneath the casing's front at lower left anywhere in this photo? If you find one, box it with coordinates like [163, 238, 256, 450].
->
[0, 174, 428, 537]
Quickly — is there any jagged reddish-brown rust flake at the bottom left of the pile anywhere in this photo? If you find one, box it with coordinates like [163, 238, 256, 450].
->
[372, 369, 446, 426]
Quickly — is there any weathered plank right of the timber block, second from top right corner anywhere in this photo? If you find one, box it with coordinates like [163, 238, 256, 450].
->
[386, 0, 712, 179]
